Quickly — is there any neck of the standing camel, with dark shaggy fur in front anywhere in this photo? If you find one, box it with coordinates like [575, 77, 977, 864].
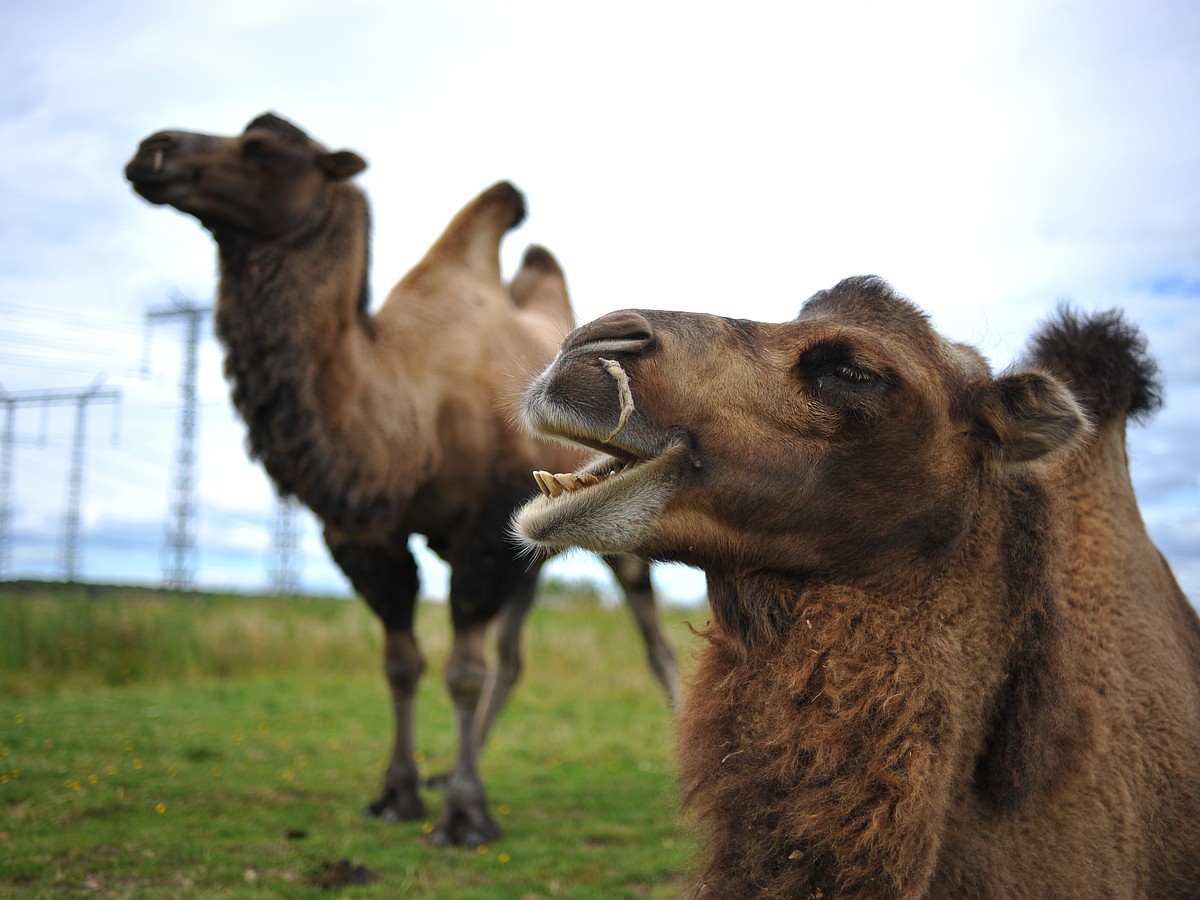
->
[206, 185, 386, 527]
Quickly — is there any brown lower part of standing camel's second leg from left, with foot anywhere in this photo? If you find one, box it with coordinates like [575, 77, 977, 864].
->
[428, 622, 500, 847]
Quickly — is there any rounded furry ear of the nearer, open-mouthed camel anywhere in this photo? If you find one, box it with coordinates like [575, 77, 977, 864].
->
[972, 372, 1088, 463]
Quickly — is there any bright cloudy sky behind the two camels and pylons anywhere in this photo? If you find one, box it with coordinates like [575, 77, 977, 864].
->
[0, 0, 1200, 602]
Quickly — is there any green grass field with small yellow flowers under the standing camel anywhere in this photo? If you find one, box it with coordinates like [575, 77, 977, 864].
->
[0, 586, 706, 899]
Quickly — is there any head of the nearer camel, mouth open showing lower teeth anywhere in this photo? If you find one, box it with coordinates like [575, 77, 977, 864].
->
[515, 278, 1087, 578]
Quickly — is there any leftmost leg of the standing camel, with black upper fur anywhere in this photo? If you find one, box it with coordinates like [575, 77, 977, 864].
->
[325, 528, 426, 821]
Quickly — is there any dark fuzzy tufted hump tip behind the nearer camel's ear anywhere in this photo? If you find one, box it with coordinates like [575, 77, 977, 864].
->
[1031, 307, 1163, 426]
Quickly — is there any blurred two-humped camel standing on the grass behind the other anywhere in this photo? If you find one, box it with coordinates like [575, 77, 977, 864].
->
[126, 114, 676, 846]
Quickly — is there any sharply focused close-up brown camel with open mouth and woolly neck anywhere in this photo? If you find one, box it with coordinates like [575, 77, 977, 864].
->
[517, 278, 1200, 898]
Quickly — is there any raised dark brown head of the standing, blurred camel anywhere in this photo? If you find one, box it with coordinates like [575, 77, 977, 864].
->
[125, 113, 366, 239]
